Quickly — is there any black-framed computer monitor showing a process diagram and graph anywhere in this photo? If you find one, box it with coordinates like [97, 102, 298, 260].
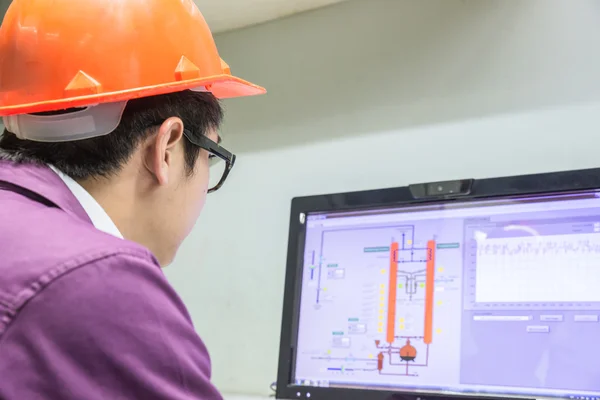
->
[277, 169, 600, 400]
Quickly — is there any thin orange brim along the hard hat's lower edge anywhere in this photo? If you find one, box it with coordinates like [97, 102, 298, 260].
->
[0, 74, 267, 116]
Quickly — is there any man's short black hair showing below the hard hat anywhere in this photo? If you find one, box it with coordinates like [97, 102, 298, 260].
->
[0, 90, 223, 180]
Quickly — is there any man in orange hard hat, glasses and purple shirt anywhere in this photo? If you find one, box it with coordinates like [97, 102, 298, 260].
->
[0, 0, 264, 400]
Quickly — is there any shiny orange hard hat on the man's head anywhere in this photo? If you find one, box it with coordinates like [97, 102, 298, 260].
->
[0, 0, 265, 116]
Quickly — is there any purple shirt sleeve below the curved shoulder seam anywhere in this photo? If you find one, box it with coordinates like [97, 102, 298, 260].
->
[0, 233, 221, 400]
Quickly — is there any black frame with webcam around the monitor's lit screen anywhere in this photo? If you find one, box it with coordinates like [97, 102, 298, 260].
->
[276, 168, 600, 400]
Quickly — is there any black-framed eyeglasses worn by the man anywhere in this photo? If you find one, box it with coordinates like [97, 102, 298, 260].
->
[183, 129, 235, 193]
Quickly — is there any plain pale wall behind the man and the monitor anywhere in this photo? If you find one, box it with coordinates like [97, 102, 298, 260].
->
[167, 0, 600, 395]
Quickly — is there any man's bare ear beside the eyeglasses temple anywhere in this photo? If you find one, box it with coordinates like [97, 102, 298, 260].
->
[144, 117, 183, 185]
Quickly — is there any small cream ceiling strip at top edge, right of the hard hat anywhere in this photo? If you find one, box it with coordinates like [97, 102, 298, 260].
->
[194, 0, 345, 33]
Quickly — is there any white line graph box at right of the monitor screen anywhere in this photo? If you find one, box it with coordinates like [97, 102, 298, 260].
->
[475, 233, 600, 303]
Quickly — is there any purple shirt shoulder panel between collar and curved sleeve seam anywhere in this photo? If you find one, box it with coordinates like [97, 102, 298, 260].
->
[0, 194, 162, 336]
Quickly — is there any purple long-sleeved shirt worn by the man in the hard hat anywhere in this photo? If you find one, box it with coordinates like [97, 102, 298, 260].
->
[0, 162, 221, 400]
